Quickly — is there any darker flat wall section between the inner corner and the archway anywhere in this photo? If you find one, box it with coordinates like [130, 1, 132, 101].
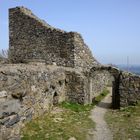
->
[66, 71, 90, 104]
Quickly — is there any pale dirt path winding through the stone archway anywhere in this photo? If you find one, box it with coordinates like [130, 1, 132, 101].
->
[88, 88, 113, 140]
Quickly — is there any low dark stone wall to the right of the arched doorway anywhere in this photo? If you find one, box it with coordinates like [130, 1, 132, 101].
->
[119, 72, 140, 107]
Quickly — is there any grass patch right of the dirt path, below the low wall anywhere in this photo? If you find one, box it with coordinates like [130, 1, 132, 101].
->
[105, 102, 140, 140]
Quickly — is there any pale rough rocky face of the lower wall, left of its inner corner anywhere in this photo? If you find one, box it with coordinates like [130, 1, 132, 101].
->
[0, 64, 65, 137]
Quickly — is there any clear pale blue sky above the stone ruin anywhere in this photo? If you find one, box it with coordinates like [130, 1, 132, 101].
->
[0, 0, 140, 65]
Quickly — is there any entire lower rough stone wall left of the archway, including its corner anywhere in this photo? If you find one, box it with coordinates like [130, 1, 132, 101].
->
[0, 63, 89, 139]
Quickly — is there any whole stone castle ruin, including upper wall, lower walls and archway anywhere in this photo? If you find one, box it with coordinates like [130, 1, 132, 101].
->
[0, 7, 140, 139]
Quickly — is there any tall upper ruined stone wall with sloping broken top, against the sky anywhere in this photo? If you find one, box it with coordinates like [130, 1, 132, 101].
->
[9, 7, 98, 69]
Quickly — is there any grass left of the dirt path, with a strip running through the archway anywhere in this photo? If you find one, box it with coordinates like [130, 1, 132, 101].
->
[21, 90, 108, 140]
